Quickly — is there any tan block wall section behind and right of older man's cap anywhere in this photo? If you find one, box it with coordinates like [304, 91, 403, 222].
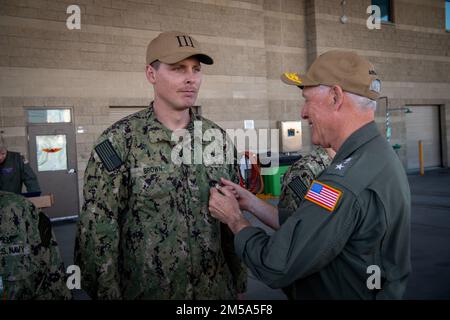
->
[311, 0, 450, 166]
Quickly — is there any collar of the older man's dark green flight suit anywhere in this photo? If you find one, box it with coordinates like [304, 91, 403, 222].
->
[333, 121, 380, 162]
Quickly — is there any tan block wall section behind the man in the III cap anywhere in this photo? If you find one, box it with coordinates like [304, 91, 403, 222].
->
[0, 0, 274, 202]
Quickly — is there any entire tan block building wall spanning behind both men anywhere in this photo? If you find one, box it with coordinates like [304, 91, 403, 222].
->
[0, 0, 450, 206]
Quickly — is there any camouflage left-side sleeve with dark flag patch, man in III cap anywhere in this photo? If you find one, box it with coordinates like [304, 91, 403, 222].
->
[74, 136, 129, 299]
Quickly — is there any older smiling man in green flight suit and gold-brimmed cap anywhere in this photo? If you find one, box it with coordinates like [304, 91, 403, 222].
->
[209, 50, 411, 299]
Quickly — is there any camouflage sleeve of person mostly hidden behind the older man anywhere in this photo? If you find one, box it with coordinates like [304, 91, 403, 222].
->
[278, 147, 332, 210]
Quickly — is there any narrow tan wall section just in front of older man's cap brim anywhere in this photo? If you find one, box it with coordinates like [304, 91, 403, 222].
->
[264, 0, 311, 153]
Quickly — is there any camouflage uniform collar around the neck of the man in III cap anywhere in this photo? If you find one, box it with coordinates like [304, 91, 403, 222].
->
[147, 101, 201, 144]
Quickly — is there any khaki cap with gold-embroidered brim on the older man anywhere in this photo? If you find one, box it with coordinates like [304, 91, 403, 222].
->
[281, 50, 381, 100]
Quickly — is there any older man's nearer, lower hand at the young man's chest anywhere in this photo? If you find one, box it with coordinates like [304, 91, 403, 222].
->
[209, 188, 250, 234]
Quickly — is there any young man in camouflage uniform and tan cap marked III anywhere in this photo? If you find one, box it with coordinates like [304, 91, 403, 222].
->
[75, 32, 247, 299]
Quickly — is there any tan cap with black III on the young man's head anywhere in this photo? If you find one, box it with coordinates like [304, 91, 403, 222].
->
[146, 31, 214, 64]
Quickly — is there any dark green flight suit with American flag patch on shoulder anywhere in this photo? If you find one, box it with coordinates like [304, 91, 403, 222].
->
[235, 122, 411, 299]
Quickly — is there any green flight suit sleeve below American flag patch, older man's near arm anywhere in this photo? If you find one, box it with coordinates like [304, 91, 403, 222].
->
[235, 183, 361, 288]
